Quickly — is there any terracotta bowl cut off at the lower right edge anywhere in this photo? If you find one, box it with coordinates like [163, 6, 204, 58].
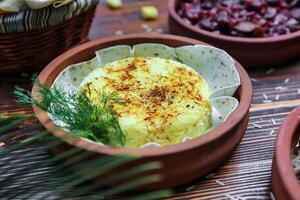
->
[272, 107, 300, 200]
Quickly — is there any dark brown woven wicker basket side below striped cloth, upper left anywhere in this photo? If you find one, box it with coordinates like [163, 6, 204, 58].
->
[0, 5, 96, 72]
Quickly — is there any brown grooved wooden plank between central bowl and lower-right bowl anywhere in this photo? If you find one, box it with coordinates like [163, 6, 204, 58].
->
[171, 107, 293, 199]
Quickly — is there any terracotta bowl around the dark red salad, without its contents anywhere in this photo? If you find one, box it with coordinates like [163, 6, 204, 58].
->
[168, 0, 300, 67]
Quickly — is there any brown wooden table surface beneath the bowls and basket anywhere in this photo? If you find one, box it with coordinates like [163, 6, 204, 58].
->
[0, 0, 300, 199]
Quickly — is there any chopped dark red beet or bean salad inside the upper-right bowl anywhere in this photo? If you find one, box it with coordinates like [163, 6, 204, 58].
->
[176, 0, 300, 37]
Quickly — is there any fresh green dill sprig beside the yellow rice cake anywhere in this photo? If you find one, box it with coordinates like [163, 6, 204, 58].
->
[14, 81, 125, 147]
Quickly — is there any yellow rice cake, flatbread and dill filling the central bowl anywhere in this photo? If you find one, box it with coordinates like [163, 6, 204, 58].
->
[15, 43, 240, 148]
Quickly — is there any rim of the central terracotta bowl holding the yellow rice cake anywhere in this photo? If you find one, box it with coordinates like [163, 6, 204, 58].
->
[32, 33, 252, 157]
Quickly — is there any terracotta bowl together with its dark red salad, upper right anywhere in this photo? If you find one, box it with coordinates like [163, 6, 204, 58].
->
[169, 0, 300, 67]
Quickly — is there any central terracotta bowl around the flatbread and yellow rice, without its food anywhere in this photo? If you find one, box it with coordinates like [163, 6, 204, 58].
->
[32, 34, 252, 189]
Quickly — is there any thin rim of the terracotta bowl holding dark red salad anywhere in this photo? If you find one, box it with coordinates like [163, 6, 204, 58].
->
[168, 0, 300, 44]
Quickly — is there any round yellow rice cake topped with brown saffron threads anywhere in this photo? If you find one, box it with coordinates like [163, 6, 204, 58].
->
[80, 57, 211, 147]
